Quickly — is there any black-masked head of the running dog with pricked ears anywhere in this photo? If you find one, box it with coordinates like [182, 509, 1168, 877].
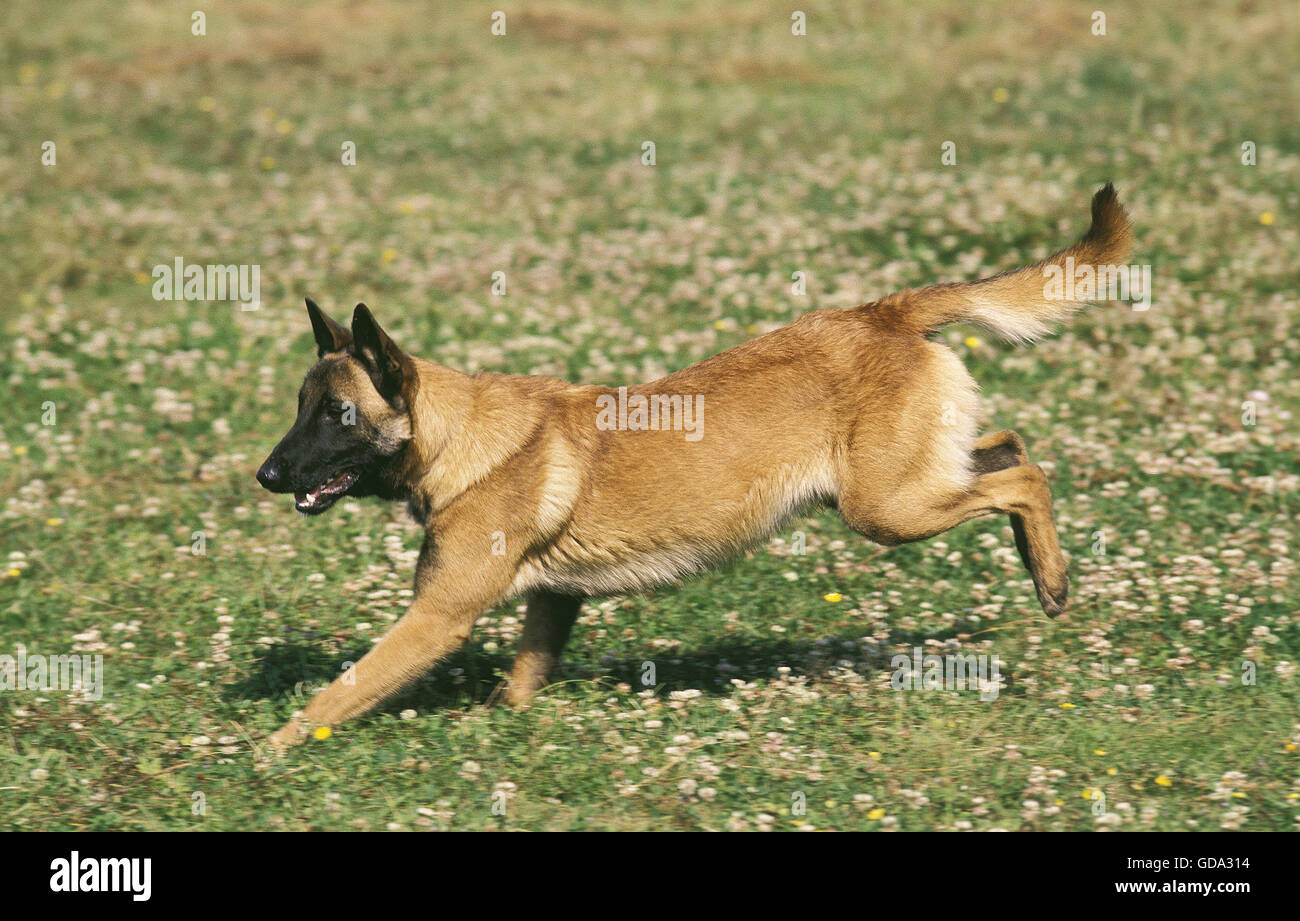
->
[257, 299, 416, 515]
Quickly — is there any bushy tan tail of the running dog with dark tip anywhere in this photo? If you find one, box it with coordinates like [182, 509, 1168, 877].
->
[874, 182, 1132, 341]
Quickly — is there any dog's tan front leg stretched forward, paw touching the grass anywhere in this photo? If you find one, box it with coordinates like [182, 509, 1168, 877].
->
[268, 528, 516, 751]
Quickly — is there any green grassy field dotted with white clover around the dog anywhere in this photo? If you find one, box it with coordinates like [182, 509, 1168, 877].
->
[0, 0, 1300, 830]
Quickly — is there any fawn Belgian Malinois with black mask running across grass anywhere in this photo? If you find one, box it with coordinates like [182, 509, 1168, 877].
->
[257, 183, 1132, 748]
